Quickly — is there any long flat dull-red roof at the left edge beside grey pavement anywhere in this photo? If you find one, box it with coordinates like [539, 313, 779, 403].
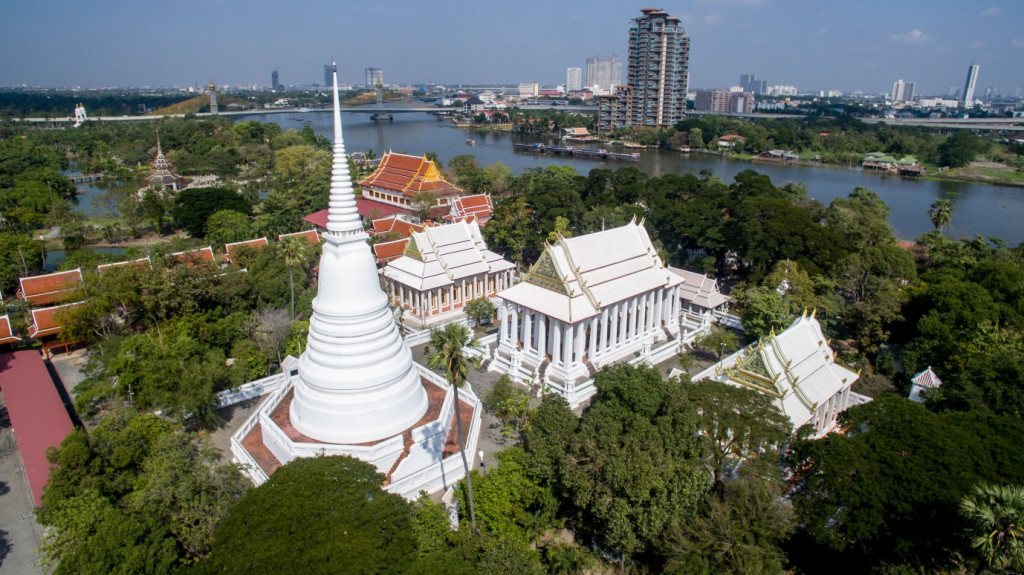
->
[0, 351, 73, 506]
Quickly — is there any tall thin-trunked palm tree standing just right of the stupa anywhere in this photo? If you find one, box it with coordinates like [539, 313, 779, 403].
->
[425, 323, 480, 531]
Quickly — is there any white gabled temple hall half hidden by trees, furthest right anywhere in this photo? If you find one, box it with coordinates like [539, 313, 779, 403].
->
[684, 313, 870, 438]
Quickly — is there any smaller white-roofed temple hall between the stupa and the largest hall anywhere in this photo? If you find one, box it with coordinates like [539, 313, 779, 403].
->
[381, 218, 515, 328]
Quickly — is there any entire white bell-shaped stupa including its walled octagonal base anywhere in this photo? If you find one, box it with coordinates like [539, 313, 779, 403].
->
[231, 64, 480, 498]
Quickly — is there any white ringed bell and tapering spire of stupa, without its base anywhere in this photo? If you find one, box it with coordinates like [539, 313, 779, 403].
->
[290, 60, 428, 444]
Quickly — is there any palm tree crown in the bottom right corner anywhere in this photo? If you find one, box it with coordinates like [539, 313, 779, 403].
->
[961, 485, 1024, 572]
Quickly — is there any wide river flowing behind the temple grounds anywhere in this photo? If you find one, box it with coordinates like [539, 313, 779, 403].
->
[82, 112, 1024, 246]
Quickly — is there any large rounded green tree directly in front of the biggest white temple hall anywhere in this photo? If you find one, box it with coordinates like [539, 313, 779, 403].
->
[561, 365, 711, 565]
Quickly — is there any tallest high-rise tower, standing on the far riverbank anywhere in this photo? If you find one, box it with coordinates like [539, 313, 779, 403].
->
[626, 8, 690, 127]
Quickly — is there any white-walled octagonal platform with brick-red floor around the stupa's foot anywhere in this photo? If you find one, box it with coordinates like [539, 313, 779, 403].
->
[231, 364, 482, 499]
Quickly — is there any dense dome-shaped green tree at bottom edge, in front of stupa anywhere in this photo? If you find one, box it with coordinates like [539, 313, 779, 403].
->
[194, 456, 419, 574]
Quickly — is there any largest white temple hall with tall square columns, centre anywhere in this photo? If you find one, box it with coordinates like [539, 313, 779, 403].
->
[488, 221, 683, 406]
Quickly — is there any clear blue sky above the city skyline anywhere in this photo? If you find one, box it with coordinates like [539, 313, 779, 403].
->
[0, 0, 1024, 94]
